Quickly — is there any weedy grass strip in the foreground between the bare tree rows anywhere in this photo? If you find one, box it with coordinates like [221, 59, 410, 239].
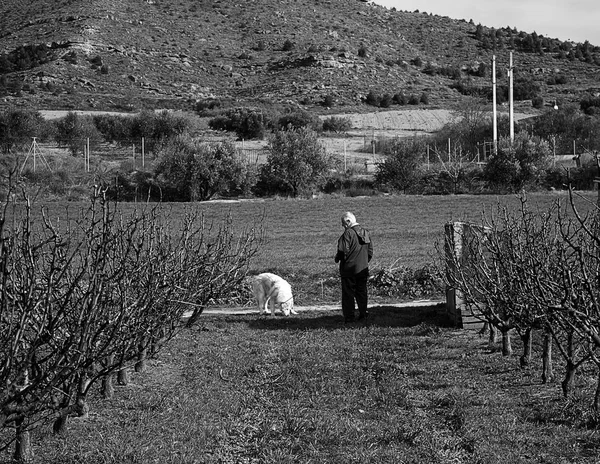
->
[15, 307, 600, 464]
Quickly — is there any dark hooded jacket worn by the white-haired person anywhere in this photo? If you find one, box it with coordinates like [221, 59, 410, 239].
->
[335, 224, 373, 275]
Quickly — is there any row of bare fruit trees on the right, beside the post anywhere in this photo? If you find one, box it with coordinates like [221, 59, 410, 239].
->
[445, 192, 600, 410]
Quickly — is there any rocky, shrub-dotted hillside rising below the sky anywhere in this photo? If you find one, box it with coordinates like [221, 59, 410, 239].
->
[0, 0, 600, 112]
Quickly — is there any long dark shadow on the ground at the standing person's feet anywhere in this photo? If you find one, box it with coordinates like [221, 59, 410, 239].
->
[241, 304, 451, 330]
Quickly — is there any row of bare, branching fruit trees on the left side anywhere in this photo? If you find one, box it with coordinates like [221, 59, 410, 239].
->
[0, 181, 262, 461]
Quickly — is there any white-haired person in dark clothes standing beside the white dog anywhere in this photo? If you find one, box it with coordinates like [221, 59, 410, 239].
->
[335, 212, 373, 323]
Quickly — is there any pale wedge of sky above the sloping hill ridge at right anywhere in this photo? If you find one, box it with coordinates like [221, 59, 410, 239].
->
[374, 0, 600, 46]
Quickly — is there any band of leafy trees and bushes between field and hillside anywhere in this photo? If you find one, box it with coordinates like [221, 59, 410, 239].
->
[0, 97, 600, 201]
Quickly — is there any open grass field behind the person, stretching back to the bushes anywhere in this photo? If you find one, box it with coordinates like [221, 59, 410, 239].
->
[30, 192, 596, 305]
